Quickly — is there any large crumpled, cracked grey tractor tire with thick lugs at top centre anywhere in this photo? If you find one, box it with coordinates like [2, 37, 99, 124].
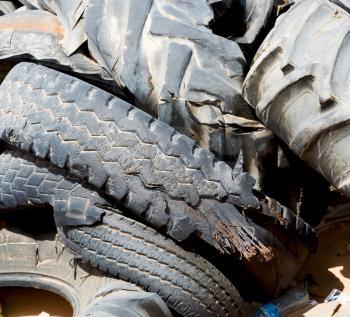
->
[85, 0, 253, 149]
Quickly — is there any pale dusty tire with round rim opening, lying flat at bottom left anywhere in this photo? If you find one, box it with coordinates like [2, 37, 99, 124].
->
[0, 228, 171, 317]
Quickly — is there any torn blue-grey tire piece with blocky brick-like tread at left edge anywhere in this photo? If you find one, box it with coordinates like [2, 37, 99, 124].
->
[0, 150, 109, 226]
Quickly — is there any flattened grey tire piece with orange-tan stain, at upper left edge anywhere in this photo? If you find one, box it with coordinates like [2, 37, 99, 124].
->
[0, 10, 112, 85]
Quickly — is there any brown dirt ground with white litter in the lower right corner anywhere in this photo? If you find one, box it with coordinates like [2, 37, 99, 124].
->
[288, 203, 350, 317]
